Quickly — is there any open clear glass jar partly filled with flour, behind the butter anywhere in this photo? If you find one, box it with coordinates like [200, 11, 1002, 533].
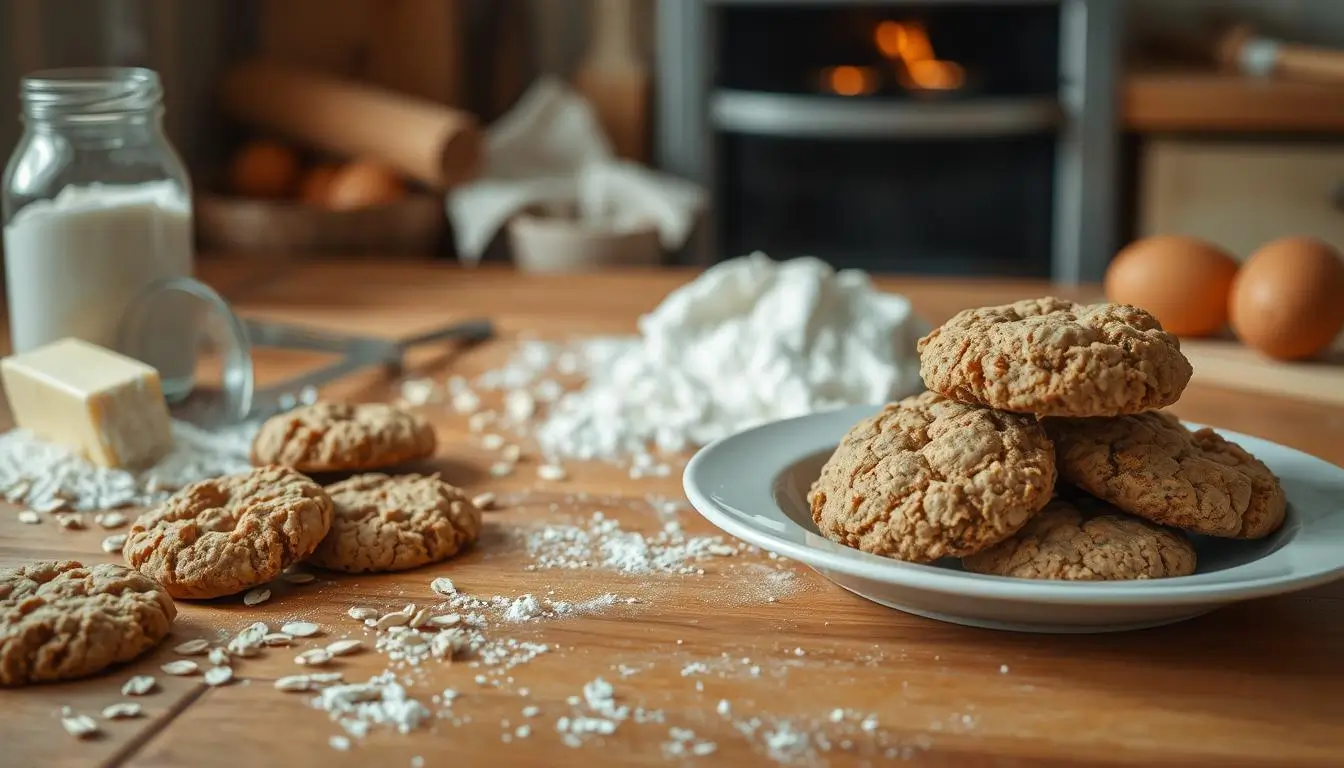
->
[4, 67, 194, 374]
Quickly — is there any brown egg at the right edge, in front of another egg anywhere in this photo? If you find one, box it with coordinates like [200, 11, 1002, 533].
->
[1230, 237, 1344, 360]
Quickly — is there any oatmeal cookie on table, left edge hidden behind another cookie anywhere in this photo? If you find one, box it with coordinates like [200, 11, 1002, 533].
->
[310, 473, 481, 573]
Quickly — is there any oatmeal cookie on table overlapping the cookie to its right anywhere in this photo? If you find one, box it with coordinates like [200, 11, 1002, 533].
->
[122, 467, 332, 600]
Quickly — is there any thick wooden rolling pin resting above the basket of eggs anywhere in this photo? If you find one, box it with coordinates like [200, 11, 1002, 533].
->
[220, 59, 482, 190]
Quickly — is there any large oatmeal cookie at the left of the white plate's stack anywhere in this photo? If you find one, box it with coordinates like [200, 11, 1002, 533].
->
[808, 391, 1055, 562]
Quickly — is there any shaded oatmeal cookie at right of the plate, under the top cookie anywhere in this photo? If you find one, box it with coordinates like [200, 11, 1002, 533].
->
[1042, 412, 1288, 538]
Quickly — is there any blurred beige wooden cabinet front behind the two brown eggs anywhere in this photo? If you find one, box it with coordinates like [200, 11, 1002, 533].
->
[1137, 137, 1344, 258]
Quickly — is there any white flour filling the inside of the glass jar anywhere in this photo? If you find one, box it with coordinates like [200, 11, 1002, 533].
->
[4, 182, 192, 357]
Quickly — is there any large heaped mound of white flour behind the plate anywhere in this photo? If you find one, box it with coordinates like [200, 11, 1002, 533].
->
[476, 253, 927, 461]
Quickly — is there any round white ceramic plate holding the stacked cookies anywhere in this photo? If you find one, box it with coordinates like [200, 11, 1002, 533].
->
[683, 406, 1344, 632]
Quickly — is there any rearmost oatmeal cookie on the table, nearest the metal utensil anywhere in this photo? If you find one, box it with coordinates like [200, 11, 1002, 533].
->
[251, 402, 437, 472]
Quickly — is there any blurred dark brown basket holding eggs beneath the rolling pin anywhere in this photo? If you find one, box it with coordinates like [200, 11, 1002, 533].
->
[195, 192, 448, 256]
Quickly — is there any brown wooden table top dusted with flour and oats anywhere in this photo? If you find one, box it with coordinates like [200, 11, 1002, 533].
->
[0, 262, 1344, 768]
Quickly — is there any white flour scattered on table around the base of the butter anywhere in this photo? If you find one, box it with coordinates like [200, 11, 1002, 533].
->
[0, 421, 258, 510]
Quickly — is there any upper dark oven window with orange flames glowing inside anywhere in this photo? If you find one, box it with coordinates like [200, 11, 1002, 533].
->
[715, 3, 1059, 100]
